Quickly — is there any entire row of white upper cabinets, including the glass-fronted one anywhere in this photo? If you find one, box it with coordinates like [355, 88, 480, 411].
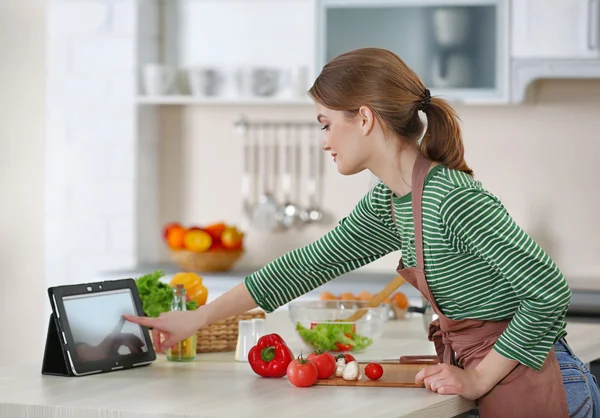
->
[137, 0, 600, 105]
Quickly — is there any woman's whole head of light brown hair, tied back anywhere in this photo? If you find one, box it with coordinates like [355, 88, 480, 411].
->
[309, 48, 473, 175]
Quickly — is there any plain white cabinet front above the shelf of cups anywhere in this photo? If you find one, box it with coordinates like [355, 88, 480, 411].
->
[165, 0, 314, 67]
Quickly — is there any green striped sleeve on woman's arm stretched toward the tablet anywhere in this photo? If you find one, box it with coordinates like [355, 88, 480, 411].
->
[244, 185, 400, 312]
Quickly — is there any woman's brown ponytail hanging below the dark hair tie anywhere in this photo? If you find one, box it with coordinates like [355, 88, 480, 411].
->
[420, 97, 473, 175]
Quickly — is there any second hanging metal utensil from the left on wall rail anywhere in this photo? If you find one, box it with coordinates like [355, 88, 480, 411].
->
[254, 125, 277, 232]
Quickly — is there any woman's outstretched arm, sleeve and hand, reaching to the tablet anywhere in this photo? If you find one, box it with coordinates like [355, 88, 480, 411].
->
[125, 186, 401, 352]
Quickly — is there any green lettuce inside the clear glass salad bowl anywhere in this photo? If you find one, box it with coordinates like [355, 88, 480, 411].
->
[296, 323, 373, 351]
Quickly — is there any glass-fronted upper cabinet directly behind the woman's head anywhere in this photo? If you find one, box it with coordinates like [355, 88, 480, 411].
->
[317, 0, 509, 103]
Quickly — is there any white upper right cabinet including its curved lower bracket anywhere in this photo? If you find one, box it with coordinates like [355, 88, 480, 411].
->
[510, 0, 600, 103]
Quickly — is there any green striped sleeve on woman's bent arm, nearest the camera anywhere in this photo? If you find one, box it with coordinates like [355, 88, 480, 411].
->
[441, 187, 571, 370]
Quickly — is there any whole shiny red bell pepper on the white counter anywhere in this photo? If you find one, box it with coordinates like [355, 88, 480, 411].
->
[248, 334, 294, 377]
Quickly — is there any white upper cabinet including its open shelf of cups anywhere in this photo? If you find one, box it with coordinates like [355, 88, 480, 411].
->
[138, 0, 316, 104]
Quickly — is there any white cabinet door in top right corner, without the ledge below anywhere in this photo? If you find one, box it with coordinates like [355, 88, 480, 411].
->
[511, 0, 600, 59]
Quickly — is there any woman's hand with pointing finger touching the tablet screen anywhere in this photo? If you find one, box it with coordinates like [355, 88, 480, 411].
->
[125, 309, 204, 353]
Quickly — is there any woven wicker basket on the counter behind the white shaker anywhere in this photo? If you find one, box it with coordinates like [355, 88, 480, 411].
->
[196, 310, 265, 353]
